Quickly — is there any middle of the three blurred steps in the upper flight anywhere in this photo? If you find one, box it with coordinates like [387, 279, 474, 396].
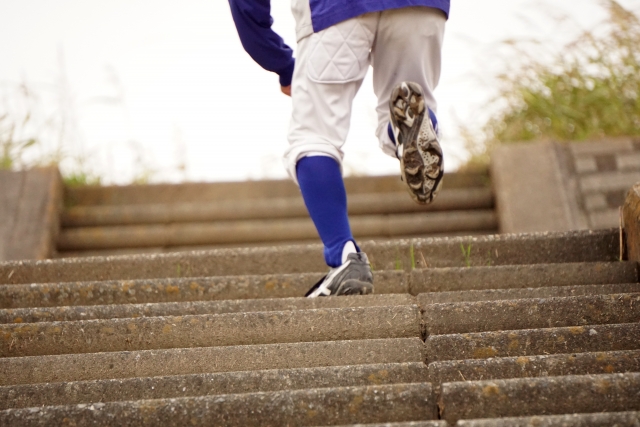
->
[61, 188, 493, 227]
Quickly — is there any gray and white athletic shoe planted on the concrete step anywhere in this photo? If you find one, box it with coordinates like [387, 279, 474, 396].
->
[305, 252, 373, 298]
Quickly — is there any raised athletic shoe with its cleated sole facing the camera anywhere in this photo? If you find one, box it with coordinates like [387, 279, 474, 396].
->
[389, 82, 444, 204]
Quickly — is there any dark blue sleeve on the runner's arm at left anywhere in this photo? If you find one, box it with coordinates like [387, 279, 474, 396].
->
[229, 0, 295, 86]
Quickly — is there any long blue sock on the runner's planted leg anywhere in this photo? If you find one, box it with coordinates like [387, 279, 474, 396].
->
[296, 156, 357, 267]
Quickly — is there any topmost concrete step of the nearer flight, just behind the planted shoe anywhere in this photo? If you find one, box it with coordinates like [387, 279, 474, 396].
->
[0, 230, 620, 291]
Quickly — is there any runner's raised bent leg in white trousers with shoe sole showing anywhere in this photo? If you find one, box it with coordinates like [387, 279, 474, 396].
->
[372, 7, 446, 203]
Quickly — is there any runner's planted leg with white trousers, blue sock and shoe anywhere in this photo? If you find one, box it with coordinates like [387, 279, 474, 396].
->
[285, 14, 378, 297]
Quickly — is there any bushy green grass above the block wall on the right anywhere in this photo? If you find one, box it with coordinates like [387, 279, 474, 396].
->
[461, 0, 640, 170]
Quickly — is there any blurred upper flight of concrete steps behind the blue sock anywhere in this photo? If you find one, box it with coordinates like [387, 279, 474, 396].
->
[57, 173, 498, 257]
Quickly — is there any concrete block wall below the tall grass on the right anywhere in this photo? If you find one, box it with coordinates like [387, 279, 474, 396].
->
[491, 138, 640, 233]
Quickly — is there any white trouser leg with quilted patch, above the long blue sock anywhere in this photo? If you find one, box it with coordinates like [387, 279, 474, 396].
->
[285, 14, 379, 180]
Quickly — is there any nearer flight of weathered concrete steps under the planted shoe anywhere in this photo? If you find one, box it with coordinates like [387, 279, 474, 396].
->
[0, 224, 640, 427]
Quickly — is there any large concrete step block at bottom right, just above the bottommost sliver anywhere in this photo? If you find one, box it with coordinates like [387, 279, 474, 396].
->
[438, 373, 640, 424]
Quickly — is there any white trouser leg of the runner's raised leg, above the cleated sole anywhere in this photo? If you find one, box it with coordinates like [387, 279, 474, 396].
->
[372, 7, 446, 156]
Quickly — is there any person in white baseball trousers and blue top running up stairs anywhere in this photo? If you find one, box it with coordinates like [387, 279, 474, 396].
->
[229, 0, 450, 297]
